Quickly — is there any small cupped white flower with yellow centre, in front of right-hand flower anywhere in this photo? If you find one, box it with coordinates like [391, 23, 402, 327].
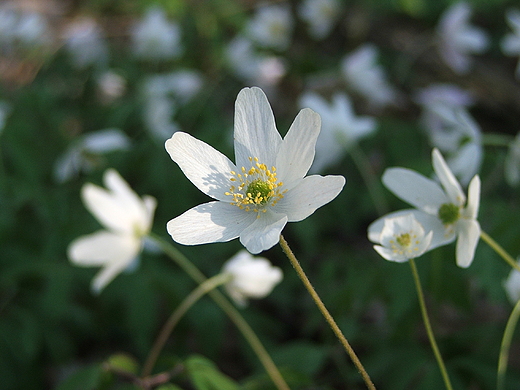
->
[374, 214, 433, 263]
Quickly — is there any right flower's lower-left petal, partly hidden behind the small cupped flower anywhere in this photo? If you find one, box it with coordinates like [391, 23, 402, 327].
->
[368, 209, 456, 251]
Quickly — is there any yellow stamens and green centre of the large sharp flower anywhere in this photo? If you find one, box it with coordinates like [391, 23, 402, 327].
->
[225, 157, 287, 216]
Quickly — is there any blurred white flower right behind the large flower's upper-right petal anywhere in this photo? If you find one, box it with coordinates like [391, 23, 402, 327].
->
[300, 92, 377, 172]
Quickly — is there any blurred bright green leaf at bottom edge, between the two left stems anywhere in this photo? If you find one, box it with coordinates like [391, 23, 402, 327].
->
[185, 355, 238, 390]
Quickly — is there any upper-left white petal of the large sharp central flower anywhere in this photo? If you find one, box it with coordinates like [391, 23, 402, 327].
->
[165, 131, 236, 201]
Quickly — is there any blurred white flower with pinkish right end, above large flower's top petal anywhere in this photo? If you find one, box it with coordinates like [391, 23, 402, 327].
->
[226, 36, 286, 87]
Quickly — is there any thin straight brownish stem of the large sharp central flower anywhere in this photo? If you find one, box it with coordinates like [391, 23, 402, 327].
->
[280, 235, 376, 390]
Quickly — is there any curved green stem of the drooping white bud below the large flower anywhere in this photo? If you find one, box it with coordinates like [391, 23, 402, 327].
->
[141, 273, 231, 377]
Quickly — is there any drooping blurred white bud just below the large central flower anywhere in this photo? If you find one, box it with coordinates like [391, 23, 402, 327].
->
[222, 250, 283, 306]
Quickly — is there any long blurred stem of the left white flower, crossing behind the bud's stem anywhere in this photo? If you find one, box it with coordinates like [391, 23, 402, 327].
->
[149, 233, 289, 390]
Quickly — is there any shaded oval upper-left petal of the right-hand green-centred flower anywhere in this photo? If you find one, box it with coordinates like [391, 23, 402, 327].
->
[382, 168, 449, 215]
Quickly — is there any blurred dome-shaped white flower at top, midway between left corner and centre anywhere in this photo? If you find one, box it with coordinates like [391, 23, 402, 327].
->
[131, 6, 182, 60]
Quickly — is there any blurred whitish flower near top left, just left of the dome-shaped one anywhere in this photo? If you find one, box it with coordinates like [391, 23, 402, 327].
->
[64, 18, 108, 69]
